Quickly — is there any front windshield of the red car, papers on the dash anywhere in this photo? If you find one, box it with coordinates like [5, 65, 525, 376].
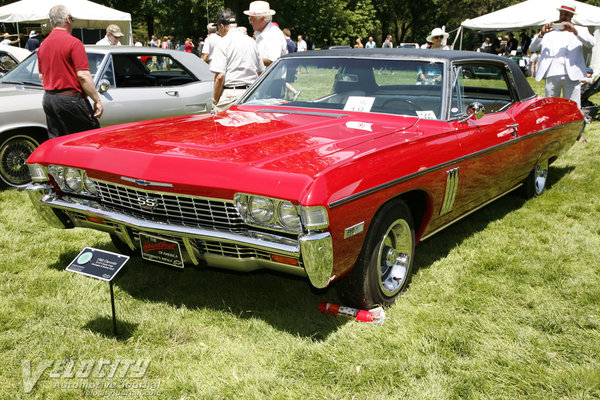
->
[240, 57, 445, 119]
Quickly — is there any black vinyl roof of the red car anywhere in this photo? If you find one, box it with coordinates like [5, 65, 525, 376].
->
[283, 48, 535, 101]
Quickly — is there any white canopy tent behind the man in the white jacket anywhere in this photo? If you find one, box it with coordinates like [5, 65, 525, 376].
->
[457, 0, 600, 74]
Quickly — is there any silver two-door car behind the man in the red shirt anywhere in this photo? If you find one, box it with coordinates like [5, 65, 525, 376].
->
[0, 46, 214, 187]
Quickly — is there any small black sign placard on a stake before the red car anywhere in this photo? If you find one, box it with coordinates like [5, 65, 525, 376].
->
[67, 247, 129, 282]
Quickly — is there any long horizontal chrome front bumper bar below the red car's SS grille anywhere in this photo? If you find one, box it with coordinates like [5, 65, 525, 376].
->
[40, 196, 300, 257]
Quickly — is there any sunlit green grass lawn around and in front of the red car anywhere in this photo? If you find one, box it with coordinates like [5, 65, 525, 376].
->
[0, 86, 600, 400]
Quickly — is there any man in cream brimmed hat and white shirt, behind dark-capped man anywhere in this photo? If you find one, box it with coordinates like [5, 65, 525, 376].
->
[244, 1, 287, 67]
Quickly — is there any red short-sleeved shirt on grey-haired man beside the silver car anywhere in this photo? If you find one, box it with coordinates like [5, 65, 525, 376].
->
[38, 29, 90, 93]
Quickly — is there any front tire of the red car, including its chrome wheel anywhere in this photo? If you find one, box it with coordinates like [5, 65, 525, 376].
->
[337, 201, 415, 309]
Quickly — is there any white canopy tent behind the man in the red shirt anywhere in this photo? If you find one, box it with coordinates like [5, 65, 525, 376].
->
[0, 0, 132, 45]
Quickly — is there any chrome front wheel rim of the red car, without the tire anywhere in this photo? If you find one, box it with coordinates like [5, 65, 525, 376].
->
[377, 219, 413, 297]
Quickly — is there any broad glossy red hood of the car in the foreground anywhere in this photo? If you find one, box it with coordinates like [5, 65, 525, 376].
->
[29, 107, 417, 200]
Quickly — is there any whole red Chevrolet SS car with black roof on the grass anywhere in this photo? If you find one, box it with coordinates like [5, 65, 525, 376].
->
[28, 49, 584, 307]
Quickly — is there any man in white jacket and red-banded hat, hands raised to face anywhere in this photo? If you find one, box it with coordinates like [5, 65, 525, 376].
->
[529, 4, 594, 107]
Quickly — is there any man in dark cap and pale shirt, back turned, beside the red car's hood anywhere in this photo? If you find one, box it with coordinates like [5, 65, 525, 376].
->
[210, 10, 264, 112]
